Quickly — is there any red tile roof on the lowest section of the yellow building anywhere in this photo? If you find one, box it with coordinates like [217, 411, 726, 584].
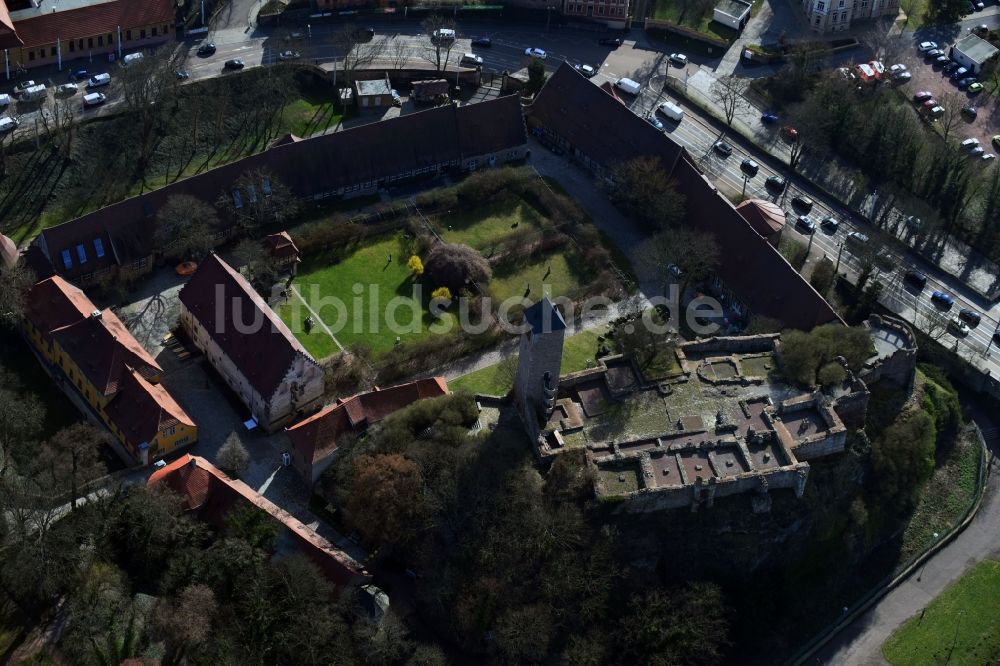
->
[104, 368, 194, 450]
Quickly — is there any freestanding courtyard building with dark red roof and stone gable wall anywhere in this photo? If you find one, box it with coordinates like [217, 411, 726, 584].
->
[180, 254, 324, 432]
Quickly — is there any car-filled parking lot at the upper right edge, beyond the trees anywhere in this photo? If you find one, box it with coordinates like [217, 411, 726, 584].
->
[900, 36, 1000, 154]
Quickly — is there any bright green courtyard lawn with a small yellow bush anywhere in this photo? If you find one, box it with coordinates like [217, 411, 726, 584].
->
[278, 236, 452, 358]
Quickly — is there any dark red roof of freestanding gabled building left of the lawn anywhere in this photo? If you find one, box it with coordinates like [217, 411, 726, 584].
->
[180, 254, 315, 399]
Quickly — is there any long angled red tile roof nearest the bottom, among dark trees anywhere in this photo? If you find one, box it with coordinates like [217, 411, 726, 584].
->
[146, 455, 369, 587]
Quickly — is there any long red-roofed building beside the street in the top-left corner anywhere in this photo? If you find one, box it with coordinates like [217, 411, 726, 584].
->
[0, 0, 176, 70]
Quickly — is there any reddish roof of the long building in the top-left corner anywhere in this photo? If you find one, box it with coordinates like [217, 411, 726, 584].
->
[0, 0, 176, 47]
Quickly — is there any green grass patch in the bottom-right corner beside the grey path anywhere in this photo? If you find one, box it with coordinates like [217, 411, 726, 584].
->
[882, 560, 1000, 666]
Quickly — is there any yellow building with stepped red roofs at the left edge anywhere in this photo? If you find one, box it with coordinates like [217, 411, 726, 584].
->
[23, 276, 198, 464]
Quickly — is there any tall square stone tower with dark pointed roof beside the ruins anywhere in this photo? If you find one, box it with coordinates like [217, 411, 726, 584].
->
[514, 296, 566, 442]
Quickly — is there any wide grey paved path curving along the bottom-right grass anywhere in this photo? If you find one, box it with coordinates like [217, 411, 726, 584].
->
[809, 406, 1000, 666]
